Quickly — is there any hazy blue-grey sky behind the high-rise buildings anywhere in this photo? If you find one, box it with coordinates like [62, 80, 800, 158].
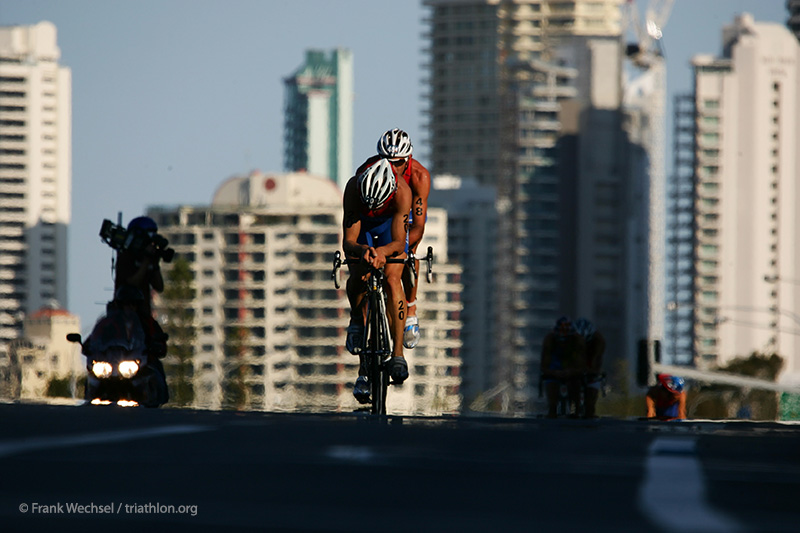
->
[0, 0, 788, 332]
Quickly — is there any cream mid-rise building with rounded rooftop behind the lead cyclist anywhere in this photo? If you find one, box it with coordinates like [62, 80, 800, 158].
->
[148, 172, 463, 414]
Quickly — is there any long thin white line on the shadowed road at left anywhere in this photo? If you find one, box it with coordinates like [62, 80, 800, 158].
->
[0, 425, 213, 458]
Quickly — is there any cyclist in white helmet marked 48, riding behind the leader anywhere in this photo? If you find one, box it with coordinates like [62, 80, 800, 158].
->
[356, 128, 431, 349]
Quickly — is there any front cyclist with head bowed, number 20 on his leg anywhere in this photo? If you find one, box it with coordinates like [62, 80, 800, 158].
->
[342, 159, 411, 403]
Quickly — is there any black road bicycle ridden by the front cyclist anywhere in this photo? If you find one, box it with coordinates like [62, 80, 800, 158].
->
[331, 246, 433, 415]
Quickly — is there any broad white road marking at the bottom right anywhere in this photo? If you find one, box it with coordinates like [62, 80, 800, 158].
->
[639, 437, 743, 533]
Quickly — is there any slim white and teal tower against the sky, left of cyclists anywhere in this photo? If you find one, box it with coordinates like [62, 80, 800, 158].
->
[283, 48, 353, 190]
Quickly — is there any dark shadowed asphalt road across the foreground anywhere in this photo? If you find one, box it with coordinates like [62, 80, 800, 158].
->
[0, 404, 800, 533]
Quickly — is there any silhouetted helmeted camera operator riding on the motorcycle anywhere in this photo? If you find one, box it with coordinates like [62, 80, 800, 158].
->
[114, 217, 164, 318]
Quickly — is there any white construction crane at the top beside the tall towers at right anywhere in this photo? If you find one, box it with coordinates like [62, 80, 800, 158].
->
[625, 0, 674, 70]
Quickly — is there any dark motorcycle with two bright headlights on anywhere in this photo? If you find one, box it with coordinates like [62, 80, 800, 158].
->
[67, 302, 169, 407]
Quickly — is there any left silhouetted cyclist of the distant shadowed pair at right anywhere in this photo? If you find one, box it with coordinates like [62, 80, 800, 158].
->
[541, 316, 586, 418]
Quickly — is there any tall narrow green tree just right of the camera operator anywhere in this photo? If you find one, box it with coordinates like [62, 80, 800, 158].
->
[159, 256, 197, 407]
